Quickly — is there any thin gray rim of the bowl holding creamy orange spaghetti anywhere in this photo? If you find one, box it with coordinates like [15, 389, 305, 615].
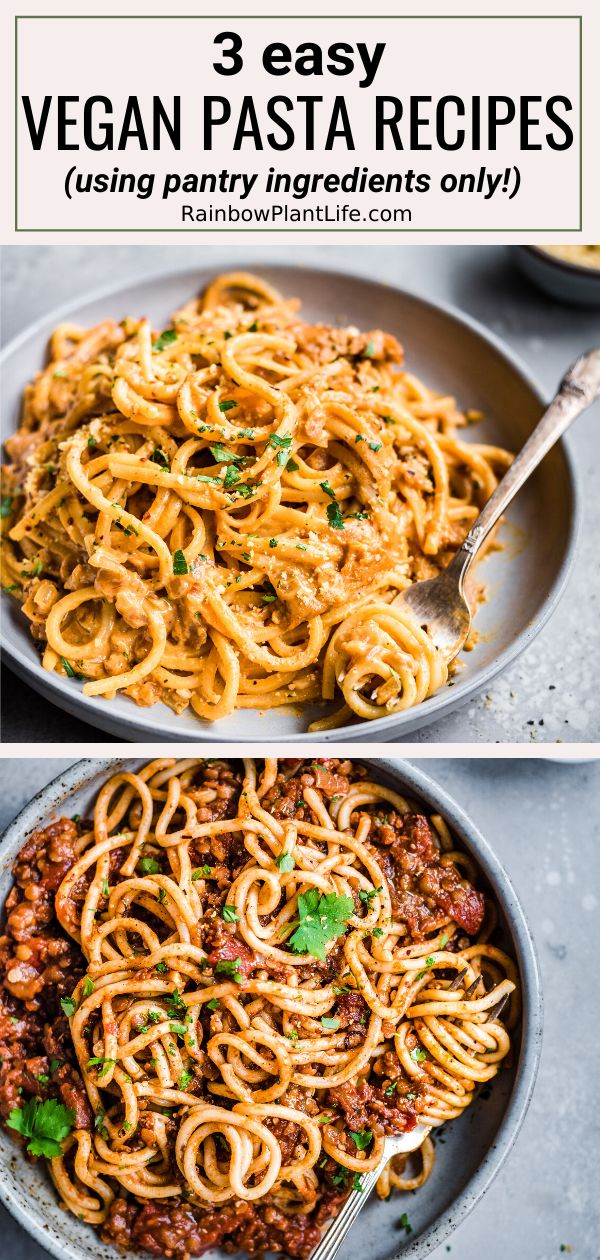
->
[0, 260, 582, 743]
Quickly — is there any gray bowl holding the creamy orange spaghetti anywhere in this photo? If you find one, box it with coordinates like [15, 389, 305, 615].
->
[1, 260, 577, 743]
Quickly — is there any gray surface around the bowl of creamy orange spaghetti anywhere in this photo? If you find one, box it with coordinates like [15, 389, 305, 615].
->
[3, 241, 600, 743]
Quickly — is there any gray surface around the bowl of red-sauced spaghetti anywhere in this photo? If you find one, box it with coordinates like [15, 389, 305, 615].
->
[0, 757, 600, 1260]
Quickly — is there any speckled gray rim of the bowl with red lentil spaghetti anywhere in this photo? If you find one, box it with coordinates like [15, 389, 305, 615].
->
[0, 756, 543, 1260]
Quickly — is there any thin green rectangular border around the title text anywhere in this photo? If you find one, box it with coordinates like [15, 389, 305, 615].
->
[14, 13, 584, 236]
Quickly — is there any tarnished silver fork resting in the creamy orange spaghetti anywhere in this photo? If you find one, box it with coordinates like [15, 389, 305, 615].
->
[393, 350, 600, 664]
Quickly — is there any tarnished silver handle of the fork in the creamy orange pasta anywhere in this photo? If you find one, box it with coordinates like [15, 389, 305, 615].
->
[449, 349, 600, 588]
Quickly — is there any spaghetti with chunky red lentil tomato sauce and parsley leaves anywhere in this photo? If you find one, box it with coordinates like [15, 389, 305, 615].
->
[0, 757, 519, 1257]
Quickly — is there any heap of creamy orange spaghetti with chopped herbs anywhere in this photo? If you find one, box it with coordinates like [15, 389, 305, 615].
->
[3, 273, 509, 730]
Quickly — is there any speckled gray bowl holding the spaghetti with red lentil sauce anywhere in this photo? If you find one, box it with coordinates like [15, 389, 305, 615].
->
[0, 757, 542, 1260]
